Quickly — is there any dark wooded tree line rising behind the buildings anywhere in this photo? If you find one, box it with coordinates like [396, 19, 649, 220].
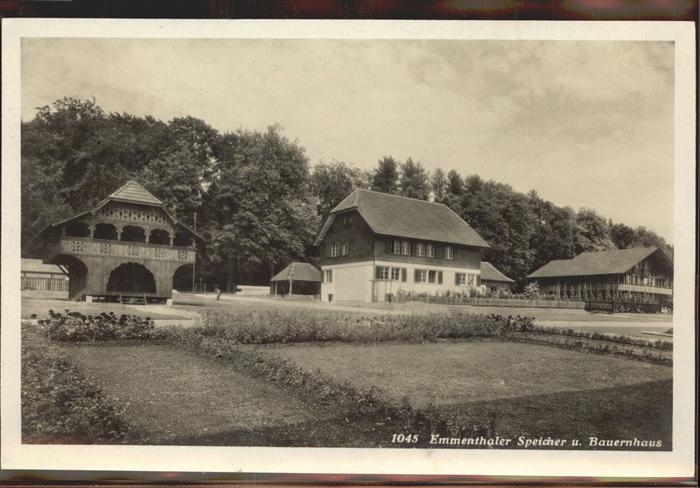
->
[21, 98, 673, 288]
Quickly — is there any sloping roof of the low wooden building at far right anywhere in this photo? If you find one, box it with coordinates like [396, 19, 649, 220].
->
[528, 247, 671, 278]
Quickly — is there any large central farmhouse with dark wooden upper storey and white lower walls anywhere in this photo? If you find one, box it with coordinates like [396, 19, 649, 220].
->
[315, 190, 489, 302]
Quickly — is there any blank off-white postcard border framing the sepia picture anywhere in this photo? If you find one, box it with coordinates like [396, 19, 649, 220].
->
[0, 18, 696, 478]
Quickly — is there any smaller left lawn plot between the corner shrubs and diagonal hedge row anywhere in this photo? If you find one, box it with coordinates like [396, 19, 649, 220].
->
[64, 344, 372, 446]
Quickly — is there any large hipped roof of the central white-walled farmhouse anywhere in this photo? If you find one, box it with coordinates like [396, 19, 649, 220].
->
[316, 189, 490, 247]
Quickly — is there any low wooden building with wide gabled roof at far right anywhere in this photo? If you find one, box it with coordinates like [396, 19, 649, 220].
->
[528, 247, 673, 305]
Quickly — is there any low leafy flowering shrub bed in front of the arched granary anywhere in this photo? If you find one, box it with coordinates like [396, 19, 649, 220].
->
[38, 309, 155, 342]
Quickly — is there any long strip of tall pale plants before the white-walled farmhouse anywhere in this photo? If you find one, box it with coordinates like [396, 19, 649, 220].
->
[174, 310, 533, 344]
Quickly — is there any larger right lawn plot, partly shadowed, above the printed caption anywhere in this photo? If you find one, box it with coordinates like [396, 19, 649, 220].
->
[270, 340, 672, 447]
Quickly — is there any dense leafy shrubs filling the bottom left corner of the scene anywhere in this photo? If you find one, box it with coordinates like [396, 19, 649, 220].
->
[22, 326, 128, 444]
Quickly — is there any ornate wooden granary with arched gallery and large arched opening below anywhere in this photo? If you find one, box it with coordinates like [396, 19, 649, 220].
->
[38, 180, 203, 302]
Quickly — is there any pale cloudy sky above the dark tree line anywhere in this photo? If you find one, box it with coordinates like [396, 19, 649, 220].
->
[21, 38, 674, 242]
